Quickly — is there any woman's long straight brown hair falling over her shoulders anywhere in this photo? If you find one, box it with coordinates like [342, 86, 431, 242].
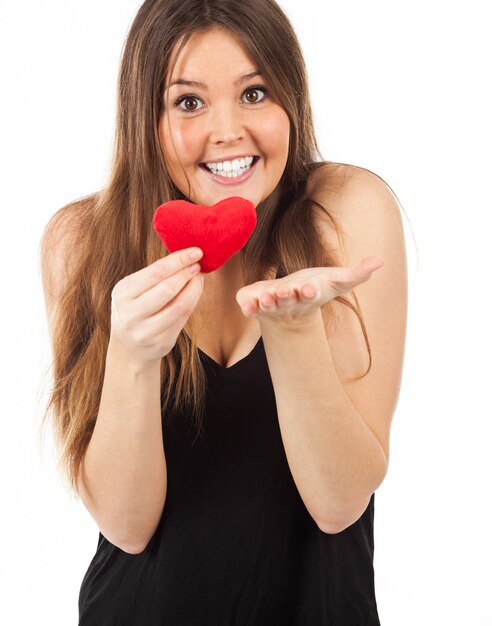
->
[42, 0, 371, 494]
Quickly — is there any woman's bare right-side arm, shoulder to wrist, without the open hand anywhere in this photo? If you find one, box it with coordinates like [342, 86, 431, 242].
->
[252, 166, 407, 533]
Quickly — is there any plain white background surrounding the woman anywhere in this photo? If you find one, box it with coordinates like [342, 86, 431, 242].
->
[0, 0, 492, 626]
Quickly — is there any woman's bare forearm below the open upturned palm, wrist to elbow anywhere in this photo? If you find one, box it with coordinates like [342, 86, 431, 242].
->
[261, 313, 387, 532]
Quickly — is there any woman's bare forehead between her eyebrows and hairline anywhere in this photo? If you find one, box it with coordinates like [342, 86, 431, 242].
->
[166, 27, 256, 83]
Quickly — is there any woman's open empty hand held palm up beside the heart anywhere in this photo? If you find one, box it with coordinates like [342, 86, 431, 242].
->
[236, 256, 384, 326]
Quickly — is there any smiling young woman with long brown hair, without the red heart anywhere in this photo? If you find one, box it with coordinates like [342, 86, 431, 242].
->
[41, 0, 407, 626]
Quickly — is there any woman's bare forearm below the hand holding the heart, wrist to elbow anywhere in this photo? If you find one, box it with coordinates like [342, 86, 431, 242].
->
[80, 342, 167, 552]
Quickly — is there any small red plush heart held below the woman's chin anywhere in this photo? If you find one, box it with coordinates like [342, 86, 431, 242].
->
[152, 196, 256, 274]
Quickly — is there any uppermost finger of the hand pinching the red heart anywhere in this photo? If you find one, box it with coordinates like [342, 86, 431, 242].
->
[123, 248, 203, 298]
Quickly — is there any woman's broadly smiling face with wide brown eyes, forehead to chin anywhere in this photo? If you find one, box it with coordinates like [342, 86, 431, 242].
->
[159, 28, 290, 206]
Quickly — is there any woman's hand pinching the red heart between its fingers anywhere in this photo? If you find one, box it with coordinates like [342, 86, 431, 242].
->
[110, 248, 204, 364]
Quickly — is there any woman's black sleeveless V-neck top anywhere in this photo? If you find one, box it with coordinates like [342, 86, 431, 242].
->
[79, 338, 380, 626]
